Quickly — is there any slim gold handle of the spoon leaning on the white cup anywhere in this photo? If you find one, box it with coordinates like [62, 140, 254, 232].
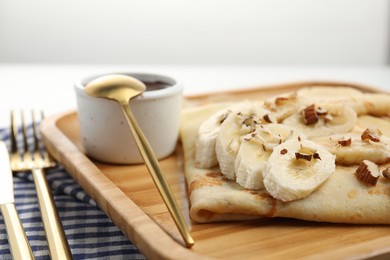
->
[121, 102, 194, 248]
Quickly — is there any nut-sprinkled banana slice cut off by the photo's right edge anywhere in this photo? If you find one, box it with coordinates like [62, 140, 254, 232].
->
[313, 133, 390, 165]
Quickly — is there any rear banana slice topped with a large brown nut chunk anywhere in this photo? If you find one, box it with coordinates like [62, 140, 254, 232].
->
[283, 103, 357, 138]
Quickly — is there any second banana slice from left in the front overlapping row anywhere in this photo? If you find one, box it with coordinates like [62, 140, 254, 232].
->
[215, 102, 269, 180]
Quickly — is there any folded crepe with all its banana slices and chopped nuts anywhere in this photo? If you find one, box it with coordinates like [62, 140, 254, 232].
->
[181, 86, 390, 224]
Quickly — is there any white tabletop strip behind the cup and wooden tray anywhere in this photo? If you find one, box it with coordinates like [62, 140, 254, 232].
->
[0, 64, 390, 127]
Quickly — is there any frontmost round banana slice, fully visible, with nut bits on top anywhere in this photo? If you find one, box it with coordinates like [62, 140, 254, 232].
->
[263, 139, 336, 201]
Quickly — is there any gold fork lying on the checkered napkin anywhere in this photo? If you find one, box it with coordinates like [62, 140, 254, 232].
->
[10, 111, 72, 259]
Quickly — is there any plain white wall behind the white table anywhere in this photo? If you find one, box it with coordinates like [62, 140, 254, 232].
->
[0, 0, 390, 65]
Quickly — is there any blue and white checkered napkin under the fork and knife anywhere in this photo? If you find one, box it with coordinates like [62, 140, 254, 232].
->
[0, 129, 145, 259]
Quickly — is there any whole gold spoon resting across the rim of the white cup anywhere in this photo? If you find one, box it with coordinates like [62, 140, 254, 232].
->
[85, 75, 194, 248]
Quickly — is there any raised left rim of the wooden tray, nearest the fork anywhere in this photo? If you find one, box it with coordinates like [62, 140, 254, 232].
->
[40, 111, 206, 259]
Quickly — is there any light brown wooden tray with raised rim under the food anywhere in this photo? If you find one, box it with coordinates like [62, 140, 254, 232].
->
[41, 82, 390, 259]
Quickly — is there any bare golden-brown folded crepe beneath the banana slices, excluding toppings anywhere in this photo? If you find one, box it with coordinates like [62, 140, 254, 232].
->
[180, 89, 390, 224]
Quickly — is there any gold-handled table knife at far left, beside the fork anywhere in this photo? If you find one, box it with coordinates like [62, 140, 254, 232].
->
[0, 141, 34, 259]
